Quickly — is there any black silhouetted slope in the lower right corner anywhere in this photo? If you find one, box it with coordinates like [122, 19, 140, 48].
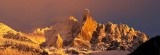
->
[129, 36, 160, 55]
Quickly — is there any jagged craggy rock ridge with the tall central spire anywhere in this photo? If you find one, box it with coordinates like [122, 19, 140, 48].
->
[42, 9, 149, 52]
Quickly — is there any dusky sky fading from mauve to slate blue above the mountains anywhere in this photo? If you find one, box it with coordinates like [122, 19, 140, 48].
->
[0, 0, 160, 37]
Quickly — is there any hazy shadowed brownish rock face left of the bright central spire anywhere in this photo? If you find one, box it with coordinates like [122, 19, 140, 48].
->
[44, 16, 79, 47]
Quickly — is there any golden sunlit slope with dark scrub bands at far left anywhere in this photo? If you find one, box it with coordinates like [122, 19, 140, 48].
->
[0, 23, 47, 55]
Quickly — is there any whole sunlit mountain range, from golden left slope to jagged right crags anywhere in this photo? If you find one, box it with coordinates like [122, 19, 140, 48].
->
[0, 9, 149, 55]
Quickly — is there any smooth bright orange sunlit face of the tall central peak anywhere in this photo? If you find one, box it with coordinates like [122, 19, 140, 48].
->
[73, 15, 97, 48]
